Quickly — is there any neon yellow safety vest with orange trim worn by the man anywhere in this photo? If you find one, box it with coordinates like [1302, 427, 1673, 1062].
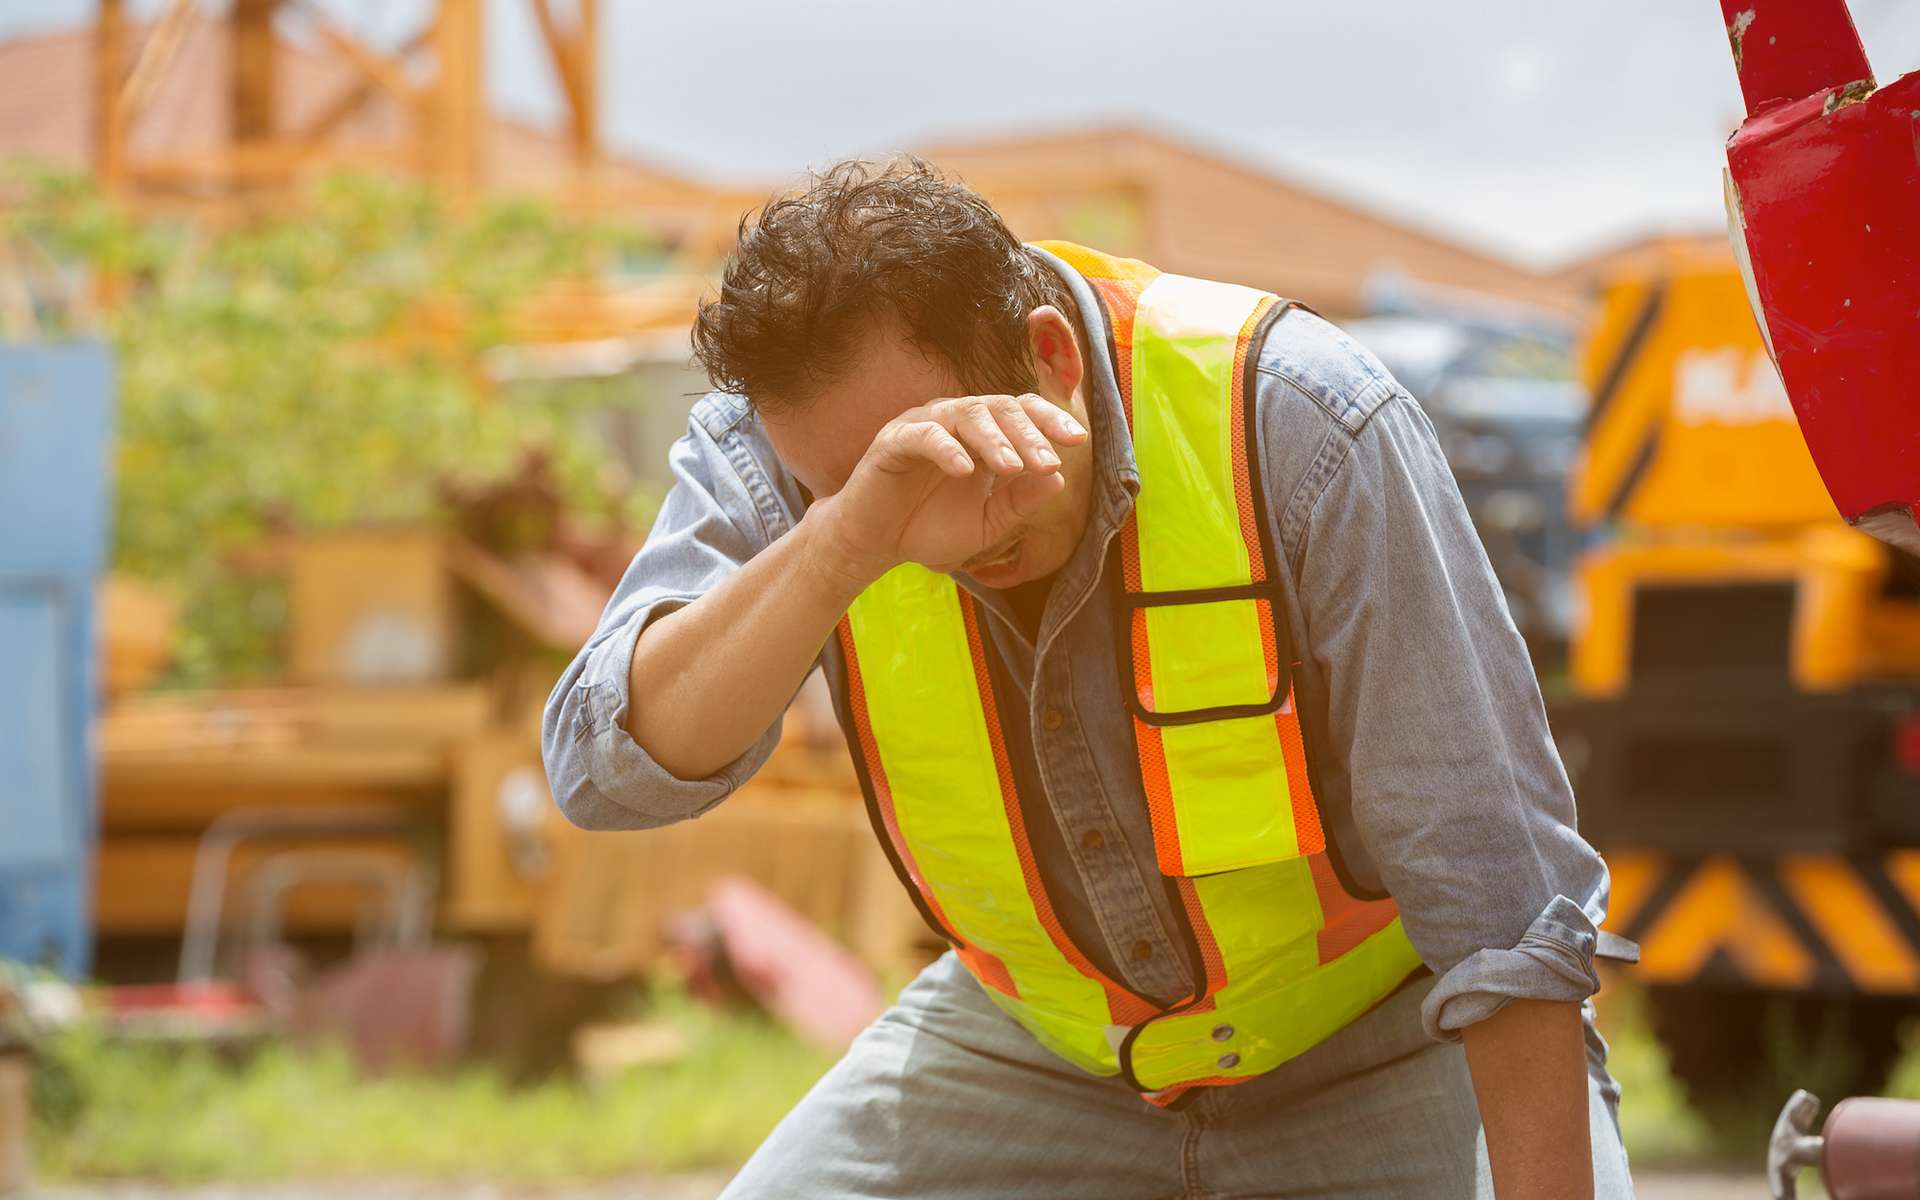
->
[839, 242, 1419, 1104]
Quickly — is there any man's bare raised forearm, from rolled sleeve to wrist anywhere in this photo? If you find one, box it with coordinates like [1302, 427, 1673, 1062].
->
[626, 505, 866, 780]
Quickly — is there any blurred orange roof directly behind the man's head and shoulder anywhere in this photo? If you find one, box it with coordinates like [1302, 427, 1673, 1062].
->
[925, 125, 1578, 313]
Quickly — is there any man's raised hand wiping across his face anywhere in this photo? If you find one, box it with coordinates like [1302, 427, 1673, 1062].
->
[816, 394, 1087, 584]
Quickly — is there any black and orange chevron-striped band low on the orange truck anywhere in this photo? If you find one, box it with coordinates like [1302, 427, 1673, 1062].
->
[1607, 851, 1920, 995]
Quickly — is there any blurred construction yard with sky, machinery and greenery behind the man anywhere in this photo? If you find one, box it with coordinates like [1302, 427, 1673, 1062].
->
[0, 0, 1920, 1198]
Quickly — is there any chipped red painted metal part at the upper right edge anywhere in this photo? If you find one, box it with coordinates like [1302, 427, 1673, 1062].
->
[1722, 0, 1920, 545]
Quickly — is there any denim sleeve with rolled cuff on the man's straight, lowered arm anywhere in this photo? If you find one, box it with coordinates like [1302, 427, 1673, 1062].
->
[1298, 390, 1607, 1039]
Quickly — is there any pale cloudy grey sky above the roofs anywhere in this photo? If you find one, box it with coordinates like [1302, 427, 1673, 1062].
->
[15, 0, 1920, 265]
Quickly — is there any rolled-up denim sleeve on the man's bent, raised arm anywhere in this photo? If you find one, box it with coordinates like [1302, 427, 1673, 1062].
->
[541, 397, 780, 829]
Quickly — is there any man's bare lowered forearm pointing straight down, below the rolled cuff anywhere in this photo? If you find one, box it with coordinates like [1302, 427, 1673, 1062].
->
[1463, 1000, 1594, 1200]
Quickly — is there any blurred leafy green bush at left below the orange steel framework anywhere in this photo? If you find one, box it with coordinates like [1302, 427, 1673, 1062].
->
[0, 175, 656, 682]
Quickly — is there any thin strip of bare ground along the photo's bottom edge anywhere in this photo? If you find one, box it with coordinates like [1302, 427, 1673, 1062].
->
[36, 1171, 1766, 1200]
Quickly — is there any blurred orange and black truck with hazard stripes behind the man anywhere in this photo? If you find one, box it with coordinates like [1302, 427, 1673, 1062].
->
[1555, 244, 1920, 1104]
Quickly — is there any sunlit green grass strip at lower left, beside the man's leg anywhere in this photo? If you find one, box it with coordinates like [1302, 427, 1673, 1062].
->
[24, 996, 831, 1183]
